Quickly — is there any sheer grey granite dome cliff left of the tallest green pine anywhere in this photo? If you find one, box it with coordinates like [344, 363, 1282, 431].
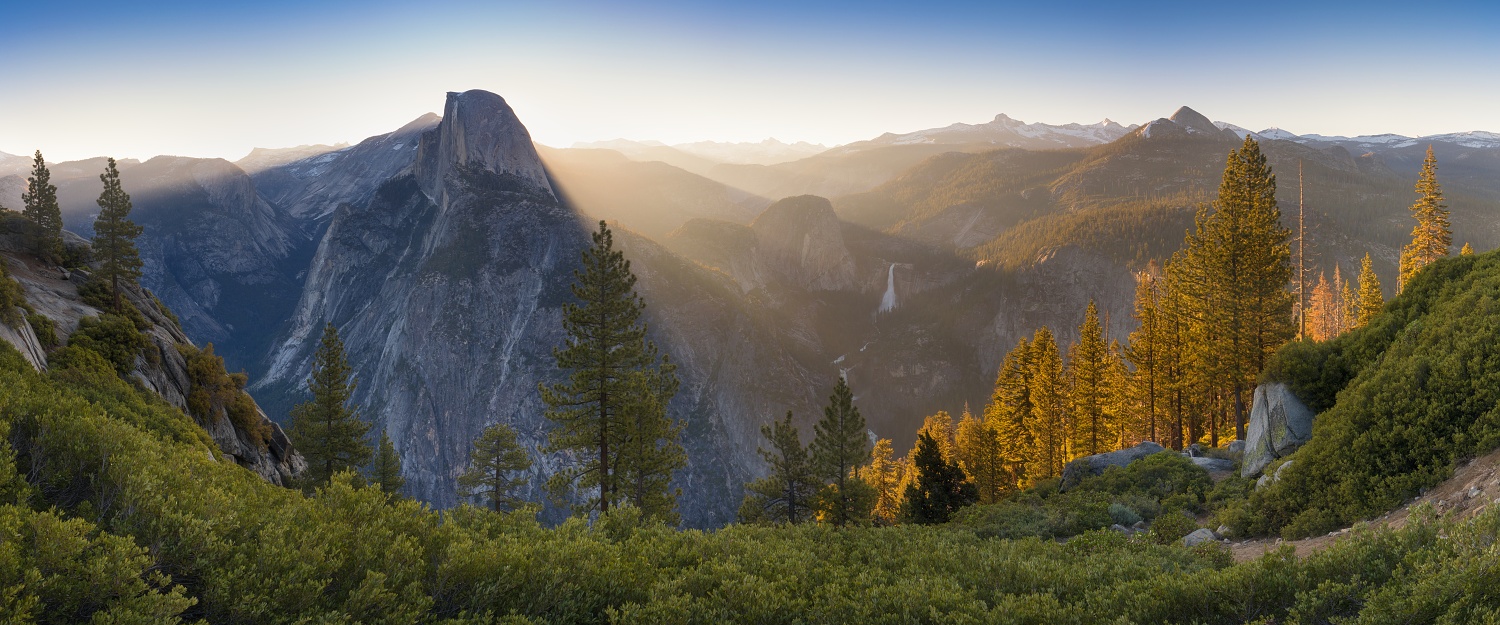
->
[257, 91, 588, 507]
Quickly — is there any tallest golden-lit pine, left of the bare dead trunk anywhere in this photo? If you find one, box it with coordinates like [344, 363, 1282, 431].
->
[1173, 135, 1295, 444]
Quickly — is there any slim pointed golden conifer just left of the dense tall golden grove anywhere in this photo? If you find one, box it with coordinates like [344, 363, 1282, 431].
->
[1068, 300, 1118, 456]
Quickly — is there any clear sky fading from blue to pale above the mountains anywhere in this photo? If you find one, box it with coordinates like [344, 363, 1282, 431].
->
[0, 0, 1500, 162]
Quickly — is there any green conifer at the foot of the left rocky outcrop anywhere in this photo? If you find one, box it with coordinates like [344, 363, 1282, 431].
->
[291, 324, 371, 489]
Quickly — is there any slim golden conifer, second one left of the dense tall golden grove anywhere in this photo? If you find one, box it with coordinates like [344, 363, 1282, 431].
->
[1026, 325, 1073, 481]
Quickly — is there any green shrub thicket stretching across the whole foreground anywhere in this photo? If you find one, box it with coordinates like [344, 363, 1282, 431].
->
[0, 346, 1500, 624]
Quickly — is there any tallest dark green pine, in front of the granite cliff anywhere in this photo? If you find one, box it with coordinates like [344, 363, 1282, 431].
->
[537, 222, 681, 514]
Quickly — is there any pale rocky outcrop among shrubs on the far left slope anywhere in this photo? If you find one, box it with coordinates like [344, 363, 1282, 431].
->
[0, 217, 308, 486]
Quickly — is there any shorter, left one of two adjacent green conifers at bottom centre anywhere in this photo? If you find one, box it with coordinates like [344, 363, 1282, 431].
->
[740, 411, 824, 525]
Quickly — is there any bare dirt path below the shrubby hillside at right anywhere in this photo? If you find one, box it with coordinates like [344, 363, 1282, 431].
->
[1230, 450, 1500, 562]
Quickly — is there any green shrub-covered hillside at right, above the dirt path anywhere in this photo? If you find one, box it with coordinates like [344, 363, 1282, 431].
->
[1230, 252, 1500, 537]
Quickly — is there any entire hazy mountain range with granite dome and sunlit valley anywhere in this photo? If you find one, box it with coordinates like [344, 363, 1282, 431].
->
[0, 98, 1500, 526]
